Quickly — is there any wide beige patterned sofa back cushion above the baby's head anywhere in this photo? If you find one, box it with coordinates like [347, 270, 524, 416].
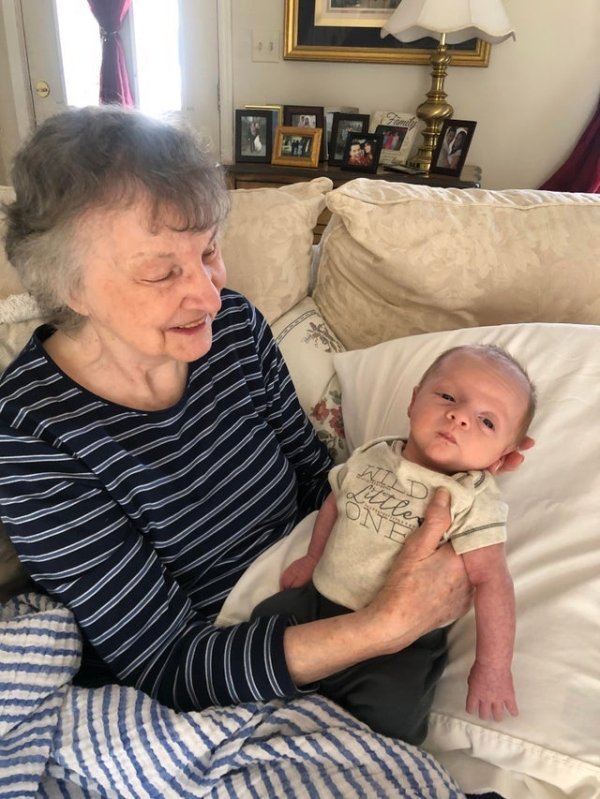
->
[313, 178, 600, 349]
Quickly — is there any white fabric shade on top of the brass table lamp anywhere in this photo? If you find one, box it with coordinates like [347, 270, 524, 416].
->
[381, 0, 515, 44]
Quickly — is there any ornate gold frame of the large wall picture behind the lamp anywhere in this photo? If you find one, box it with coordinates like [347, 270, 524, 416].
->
[283, 0, 491, 67]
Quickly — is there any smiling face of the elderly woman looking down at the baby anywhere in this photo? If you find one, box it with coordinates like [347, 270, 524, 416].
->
[69, 202, 225, 365]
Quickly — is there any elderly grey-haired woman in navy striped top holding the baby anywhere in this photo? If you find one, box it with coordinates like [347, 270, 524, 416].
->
[0, 108, 478, 709]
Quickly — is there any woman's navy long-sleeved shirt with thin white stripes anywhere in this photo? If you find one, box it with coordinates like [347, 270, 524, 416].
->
[0, 290, 331, 710]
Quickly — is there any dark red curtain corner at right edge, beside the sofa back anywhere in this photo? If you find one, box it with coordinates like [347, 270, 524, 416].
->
[541, 97, 600, 194]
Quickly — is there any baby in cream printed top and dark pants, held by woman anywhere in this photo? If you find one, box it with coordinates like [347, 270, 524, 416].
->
[254, 345, 536, 743]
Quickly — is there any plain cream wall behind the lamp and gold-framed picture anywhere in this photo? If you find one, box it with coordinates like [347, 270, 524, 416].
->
[233, 0, 600, 188]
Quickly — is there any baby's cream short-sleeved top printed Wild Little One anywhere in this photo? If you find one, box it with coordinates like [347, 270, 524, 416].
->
[313, 437, 508, 610]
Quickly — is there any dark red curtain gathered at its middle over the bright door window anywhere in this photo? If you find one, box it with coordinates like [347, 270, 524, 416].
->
[88, 0, 133, 106]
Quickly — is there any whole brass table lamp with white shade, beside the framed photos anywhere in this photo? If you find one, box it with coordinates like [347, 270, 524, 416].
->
[381, 0, 515, 172]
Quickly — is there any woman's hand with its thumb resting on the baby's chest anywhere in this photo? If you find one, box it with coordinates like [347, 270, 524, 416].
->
[368, 488, 473, 652]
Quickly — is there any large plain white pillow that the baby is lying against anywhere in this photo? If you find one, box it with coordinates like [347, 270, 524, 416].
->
[334, 324, 600, 799]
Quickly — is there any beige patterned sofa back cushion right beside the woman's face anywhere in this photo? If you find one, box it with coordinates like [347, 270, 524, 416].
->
[220, 177, 333, 322]
